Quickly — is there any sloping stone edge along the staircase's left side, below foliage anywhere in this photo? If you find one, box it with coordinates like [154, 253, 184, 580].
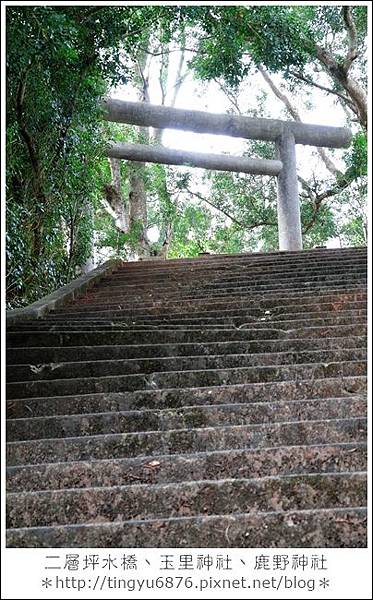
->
[6, 259, 123, 325]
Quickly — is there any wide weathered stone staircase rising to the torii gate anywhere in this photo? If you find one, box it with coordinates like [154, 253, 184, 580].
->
[7, 248, 366, 547]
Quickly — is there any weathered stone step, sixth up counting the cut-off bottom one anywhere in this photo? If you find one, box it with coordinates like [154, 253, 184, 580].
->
[7, 377, 366, 418]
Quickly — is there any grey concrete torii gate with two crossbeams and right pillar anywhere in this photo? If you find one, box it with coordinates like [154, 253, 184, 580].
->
[103, 98, 351, 250]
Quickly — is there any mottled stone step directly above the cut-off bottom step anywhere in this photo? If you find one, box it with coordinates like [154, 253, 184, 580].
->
[7, 473, 367, 527]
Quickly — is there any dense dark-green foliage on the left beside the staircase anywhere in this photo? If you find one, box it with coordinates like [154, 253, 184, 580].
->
[6, 6, 168, 306]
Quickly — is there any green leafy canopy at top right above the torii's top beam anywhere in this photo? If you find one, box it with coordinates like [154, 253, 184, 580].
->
[182, 5, 367, 87]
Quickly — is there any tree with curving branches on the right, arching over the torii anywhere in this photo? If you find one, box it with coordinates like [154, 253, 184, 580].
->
[182, 6, 367, 246]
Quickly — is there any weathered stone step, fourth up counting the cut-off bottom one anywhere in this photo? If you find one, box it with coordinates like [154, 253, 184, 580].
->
[7, 417, 367, 466]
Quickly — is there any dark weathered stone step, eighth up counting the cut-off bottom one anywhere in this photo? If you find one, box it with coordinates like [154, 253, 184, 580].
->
[7, 348, 367, 382]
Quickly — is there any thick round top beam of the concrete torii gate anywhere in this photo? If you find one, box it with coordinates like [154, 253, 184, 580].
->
[102, 98, 352, 148]
